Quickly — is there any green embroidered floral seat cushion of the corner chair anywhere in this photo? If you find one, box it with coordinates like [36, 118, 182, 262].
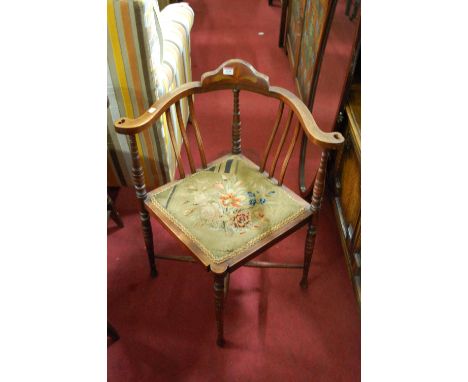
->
[146, 155, 311, 264]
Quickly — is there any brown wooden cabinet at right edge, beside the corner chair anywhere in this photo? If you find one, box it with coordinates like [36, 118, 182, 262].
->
[330, 83, 361, 304]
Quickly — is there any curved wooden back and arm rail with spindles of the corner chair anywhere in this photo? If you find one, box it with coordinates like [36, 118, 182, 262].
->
[115, 59, 344, 191]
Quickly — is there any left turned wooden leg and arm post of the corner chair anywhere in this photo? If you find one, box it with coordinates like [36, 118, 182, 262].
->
[129, 135, 158, 277]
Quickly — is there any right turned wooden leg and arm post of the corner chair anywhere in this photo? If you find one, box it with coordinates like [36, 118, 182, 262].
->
[299, 150, 328, 289]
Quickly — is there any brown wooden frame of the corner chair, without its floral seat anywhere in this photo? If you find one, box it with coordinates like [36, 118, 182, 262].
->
[115, 59, 344, 346]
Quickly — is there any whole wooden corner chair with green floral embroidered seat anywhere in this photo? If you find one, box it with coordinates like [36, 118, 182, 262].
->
[115, 59, 344, 346]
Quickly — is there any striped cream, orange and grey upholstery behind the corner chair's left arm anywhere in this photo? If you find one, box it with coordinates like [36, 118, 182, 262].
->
[107, 0, 194, 188]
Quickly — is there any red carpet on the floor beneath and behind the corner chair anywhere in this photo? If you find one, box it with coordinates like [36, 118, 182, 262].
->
[107, 0, 360, 381]
